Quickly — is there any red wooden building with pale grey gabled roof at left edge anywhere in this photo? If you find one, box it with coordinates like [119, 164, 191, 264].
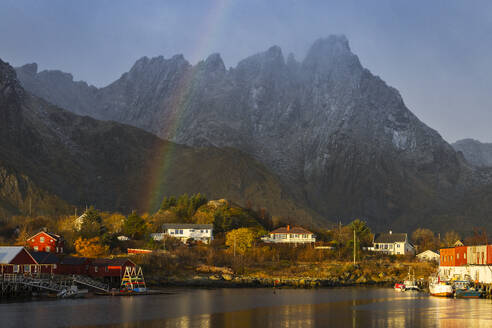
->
[0, 246, 38, 274]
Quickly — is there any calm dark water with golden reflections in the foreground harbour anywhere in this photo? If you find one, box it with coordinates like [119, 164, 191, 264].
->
[0, 288, 492, 328]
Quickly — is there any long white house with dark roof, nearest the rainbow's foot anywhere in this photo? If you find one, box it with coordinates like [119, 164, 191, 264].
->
[151, 223, 214, 244]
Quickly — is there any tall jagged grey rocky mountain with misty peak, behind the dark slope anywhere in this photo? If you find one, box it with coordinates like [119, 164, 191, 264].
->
[12, 36, 491, 230]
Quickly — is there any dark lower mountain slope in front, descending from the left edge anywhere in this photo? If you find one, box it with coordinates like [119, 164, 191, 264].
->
[0, 60, 323, 222]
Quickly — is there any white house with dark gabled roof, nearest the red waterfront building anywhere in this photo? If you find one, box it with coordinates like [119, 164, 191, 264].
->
[368, 230, 415, 255]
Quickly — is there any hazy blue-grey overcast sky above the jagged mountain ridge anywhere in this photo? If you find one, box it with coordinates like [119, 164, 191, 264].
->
[0, 0, 492, 142]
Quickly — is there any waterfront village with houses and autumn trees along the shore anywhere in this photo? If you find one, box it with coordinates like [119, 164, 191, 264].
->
[0, 195, 492, 298]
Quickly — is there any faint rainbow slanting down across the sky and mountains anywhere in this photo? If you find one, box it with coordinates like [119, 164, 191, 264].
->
[141, 0, 232, 212]
